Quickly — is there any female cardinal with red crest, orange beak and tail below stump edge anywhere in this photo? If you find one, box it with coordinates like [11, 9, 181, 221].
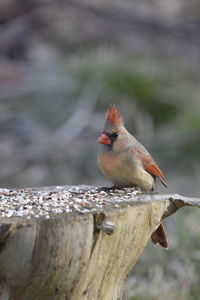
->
[98, 105, 168, 248]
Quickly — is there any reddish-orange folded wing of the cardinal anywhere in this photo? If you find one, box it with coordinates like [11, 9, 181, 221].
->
[133, 148, 167, 187]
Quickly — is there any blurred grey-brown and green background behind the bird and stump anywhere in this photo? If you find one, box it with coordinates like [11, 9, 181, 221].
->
[0, 0, 200, 300]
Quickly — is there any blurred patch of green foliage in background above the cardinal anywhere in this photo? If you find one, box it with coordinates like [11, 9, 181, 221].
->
[72, 58, 182, 125]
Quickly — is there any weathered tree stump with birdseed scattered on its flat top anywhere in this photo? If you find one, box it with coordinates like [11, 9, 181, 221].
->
[0, 186, 200, 300]
